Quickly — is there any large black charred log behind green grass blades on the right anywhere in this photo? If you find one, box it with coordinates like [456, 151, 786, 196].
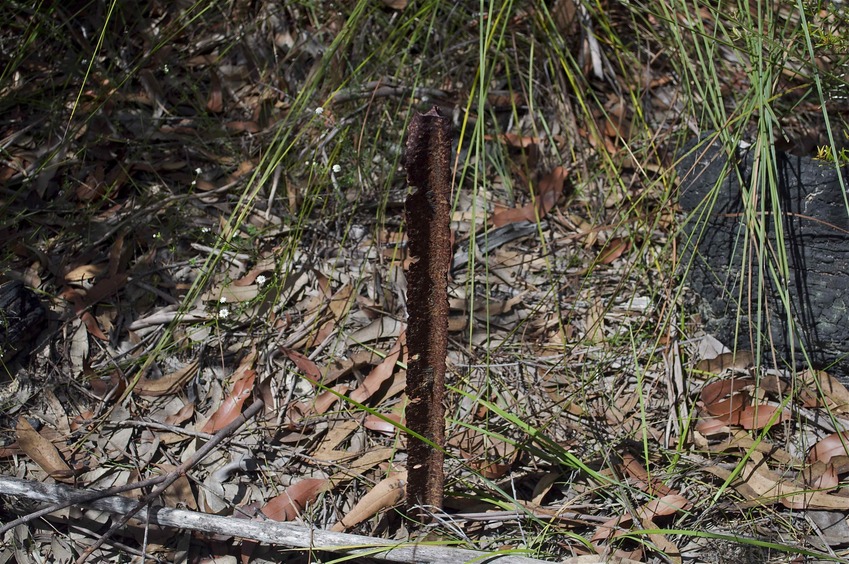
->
[677, 140, 849, 381]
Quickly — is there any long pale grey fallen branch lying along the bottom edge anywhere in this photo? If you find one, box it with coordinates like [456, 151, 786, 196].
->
[0, 476, 544, 564]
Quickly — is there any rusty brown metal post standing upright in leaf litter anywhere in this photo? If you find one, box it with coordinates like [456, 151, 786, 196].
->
[406, 103, 451, 521]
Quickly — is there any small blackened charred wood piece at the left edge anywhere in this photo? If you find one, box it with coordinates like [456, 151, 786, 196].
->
[0, 281, 47, 369]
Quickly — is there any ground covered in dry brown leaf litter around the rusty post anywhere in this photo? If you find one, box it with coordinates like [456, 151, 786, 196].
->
[0, 1, 849, 561]
